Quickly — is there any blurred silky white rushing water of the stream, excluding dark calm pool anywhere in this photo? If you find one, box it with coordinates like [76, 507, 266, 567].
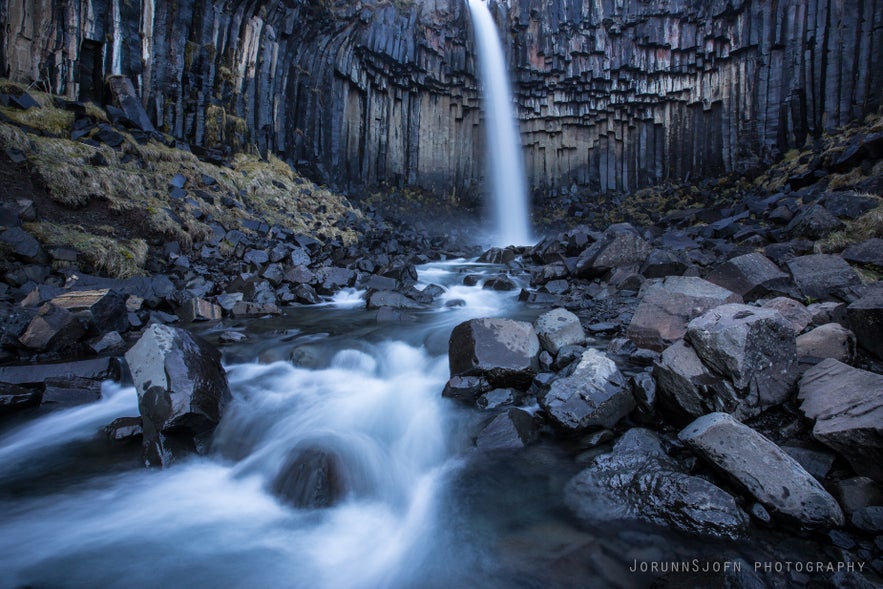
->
[0, 264, 514, 589]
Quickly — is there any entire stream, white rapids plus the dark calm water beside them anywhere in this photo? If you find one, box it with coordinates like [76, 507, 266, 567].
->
[0, 262, 828, 589]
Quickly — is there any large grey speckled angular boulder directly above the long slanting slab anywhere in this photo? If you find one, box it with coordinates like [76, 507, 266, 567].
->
[686, 304, 797, 408]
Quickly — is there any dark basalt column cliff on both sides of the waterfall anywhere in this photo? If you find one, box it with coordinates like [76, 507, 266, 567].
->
[0, 0, 883, 197]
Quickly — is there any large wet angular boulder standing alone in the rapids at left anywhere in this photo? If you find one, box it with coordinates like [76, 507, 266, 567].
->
[126, 324, 230, 466]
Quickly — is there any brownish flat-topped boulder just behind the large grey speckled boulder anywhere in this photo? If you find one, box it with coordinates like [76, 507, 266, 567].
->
[626, 276, 742, 351]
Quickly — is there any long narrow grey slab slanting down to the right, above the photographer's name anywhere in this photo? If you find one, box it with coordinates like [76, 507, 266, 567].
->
[678, 413, 844, 527]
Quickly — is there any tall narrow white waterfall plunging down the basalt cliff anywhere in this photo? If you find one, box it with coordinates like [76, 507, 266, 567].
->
[468, 0, 531, 246]
